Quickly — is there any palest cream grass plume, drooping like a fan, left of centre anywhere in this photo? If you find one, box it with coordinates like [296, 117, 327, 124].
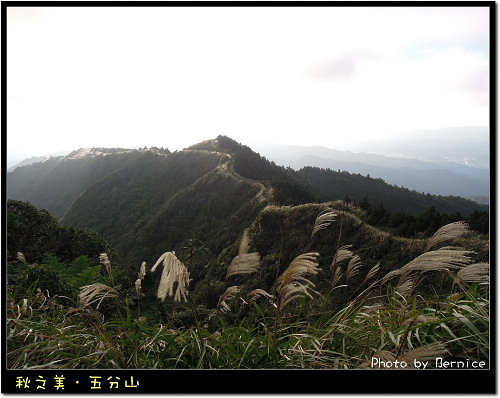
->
[151, 252, 191, 302]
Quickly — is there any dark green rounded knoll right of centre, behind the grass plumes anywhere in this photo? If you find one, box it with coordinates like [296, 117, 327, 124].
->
[187, 201, 489, 307]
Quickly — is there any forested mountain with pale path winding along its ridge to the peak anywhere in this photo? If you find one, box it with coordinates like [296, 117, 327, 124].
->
[7, 136, 487, 261]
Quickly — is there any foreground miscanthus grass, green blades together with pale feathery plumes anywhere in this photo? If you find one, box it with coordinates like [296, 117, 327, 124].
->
[6, 209, 490, 369]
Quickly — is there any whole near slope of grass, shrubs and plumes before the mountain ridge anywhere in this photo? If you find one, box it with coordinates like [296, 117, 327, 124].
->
[7, 197, 489, 369]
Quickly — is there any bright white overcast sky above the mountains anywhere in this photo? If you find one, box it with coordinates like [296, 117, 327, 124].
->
[7, 3, 490, 164]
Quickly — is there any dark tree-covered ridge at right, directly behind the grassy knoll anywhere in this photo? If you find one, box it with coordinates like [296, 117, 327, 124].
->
[298, 167, 488, 216]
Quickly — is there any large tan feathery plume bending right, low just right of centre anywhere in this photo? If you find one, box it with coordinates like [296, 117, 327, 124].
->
[276, 253, 319, 309]
